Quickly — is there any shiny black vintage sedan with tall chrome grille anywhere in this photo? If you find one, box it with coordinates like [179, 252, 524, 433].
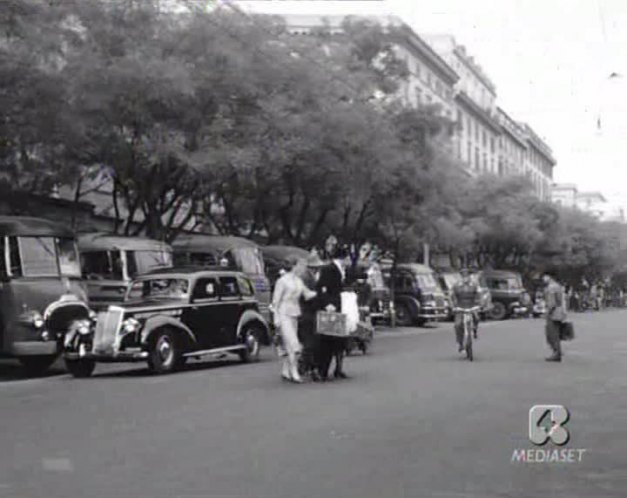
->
[65, 268, 270, 377]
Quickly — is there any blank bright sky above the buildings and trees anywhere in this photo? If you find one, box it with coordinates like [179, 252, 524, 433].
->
[236, 0, 627, 209]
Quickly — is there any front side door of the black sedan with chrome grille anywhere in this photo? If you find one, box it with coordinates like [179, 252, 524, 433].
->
[184, 277, 222, 350]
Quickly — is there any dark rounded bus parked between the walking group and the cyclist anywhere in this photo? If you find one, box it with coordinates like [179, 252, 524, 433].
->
[383, 263, 447, 326]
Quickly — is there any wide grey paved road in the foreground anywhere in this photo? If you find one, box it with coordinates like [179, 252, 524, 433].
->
[0, 311, 627, 498]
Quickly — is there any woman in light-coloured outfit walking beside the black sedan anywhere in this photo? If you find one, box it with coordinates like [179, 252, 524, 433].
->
[272, 258, 316, 383]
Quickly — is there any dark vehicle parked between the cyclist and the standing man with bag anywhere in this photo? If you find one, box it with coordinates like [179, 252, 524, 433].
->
[479, 270, 532, 320]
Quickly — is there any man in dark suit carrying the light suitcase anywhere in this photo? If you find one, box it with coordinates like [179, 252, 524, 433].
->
[316, 249, 347, 380]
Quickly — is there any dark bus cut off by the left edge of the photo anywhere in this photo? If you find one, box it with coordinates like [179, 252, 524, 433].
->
[0, 216, 90, 372]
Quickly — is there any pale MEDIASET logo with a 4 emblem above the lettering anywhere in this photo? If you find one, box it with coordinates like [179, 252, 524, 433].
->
[512, 405, 587, 463]
